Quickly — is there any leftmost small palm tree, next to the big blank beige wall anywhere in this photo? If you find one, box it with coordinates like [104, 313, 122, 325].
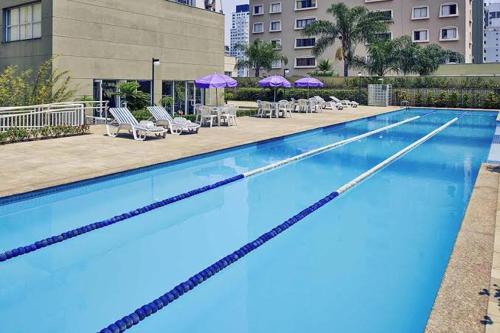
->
[236, 39, 288, 77]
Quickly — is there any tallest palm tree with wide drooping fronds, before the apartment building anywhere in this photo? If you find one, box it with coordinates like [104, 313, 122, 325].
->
[304, 3, 387, 76]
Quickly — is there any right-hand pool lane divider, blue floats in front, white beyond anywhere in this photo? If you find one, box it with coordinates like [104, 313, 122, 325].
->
[99, 117, 460, 333]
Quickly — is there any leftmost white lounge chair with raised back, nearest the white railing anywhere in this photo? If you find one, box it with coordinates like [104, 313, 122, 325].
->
[106, 108, 168, 141]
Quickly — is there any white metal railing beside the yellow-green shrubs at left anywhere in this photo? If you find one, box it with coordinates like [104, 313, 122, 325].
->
[0, 102, 85, 131]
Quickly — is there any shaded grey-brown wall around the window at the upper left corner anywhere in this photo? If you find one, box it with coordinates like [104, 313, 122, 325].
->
[0, 0, 52, 71]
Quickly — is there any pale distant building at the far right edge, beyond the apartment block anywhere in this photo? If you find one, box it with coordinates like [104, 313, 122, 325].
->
[483, 0, 500, 63]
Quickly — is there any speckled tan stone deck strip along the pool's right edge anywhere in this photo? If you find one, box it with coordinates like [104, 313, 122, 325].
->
[426, 164, 500, 333]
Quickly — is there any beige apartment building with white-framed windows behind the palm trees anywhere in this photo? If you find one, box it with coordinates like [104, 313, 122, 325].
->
[250, 0, 473, 75]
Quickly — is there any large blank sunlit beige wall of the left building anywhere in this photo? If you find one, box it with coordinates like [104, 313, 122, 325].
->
[53, 0, 224, 100]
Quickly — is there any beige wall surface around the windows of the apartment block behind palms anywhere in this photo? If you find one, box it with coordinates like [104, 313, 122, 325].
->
[250, 0, 472, 75]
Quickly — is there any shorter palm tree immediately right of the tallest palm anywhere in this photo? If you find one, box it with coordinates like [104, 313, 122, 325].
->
[353, 39, 399, 76]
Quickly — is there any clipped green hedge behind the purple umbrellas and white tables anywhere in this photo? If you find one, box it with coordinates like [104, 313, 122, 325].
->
[226, 88, 368, 104]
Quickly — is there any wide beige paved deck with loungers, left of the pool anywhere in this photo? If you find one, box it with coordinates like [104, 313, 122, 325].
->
[0, 106, 400, 197]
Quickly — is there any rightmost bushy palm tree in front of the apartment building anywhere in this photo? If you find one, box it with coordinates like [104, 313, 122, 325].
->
[415, 44, 464, 75]
